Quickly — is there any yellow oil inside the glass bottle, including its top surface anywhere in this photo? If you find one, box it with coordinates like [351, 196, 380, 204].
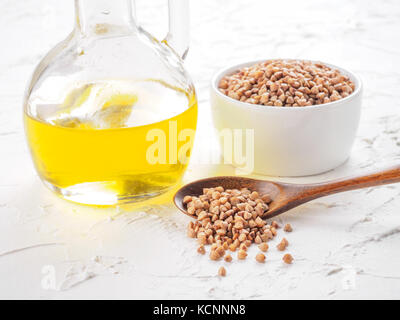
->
[25, 80, 197, 205]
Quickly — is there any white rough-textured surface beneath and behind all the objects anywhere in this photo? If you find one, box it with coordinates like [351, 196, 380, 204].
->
[0, 0, 400, 299]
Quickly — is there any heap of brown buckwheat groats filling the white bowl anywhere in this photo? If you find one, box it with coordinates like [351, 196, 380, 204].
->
[219, 59, 355, 108]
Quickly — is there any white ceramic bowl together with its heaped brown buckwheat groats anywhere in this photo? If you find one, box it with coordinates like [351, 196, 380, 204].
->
[211, 59, 362, 177]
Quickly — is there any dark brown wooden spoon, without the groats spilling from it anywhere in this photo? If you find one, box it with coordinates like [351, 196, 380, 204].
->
[174, 166, 400, 219]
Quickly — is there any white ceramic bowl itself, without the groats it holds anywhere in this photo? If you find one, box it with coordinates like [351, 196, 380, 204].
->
[211, 60, 362, 177]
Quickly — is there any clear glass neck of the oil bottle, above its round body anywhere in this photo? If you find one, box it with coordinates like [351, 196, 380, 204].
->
[75, 0, 136, 36]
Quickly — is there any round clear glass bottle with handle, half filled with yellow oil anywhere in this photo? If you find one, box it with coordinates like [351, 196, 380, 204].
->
[24, 0, 197, 205]
